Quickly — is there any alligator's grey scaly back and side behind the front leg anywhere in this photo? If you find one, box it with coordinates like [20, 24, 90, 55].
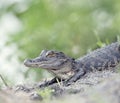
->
[76, 42, 120, 71]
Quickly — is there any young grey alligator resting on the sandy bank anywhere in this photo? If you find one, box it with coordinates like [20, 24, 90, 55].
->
[24, 42, 120, 86]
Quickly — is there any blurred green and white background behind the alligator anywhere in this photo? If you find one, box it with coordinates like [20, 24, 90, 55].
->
[0, 0, 120, 83]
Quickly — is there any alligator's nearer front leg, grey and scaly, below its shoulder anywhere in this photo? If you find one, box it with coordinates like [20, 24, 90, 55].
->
[64, 68, 86, 86]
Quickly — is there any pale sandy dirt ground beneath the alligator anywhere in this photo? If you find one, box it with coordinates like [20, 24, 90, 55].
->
[0, 70, 120, 103]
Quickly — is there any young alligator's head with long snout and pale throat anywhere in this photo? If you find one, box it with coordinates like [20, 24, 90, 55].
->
[24, 50, 75, 79]
